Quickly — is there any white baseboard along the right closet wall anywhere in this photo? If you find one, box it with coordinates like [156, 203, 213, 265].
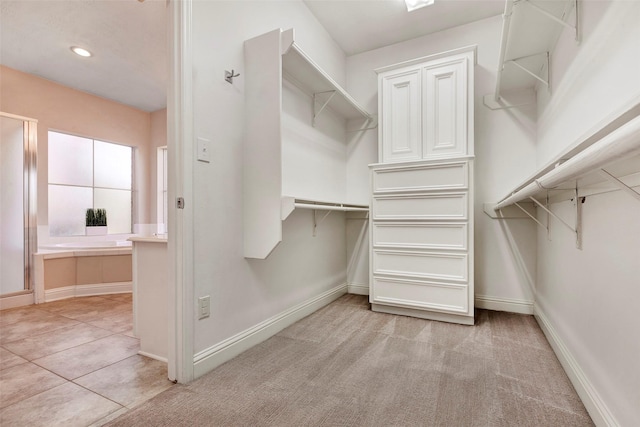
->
[534, 304, 619, 427]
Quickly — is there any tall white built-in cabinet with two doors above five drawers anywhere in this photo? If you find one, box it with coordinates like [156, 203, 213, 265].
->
[369, 46, 475, 324]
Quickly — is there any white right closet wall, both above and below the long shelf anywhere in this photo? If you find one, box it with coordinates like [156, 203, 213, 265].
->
[536, 1, 640, 426]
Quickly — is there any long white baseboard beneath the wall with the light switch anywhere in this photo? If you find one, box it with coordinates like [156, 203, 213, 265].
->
[193, 283, 347, 378]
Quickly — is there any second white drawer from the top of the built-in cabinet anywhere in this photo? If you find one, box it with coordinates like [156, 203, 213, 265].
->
[372, 192, 468, 220]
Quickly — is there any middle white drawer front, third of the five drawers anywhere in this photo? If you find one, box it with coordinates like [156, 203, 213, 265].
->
[371, 222, 468, 250]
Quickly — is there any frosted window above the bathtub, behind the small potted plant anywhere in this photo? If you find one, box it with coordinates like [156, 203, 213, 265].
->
[48, 132, 133, 236]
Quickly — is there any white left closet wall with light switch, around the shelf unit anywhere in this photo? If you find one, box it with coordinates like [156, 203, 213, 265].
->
[193, 1, 347, 353]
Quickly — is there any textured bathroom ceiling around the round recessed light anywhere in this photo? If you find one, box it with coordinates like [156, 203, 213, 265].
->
[0, 0, 167, 111]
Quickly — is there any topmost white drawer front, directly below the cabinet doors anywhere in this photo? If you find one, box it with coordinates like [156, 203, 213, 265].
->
[373, 162, 469, 193]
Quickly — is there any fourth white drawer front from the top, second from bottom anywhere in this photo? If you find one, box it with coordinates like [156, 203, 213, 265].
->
[373, 249, 469, 282]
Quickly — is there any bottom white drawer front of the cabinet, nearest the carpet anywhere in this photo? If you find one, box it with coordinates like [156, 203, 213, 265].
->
[371, 277, 469, 314]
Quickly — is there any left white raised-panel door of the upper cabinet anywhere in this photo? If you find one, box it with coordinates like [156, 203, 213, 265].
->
[381, 69, 422, 163]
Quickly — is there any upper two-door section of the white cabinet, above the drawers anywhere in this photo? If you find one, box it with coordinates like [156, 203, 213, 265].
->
[376, 48, 475, 163]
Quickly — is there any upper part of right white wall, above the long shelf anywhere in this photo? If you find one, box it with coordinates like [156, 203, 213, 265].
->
[537, 0, 640, 166]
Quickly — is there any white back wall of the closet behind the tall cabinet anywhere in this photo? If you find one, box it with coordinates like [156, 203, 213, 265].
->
[347, 16, 535, 305]
